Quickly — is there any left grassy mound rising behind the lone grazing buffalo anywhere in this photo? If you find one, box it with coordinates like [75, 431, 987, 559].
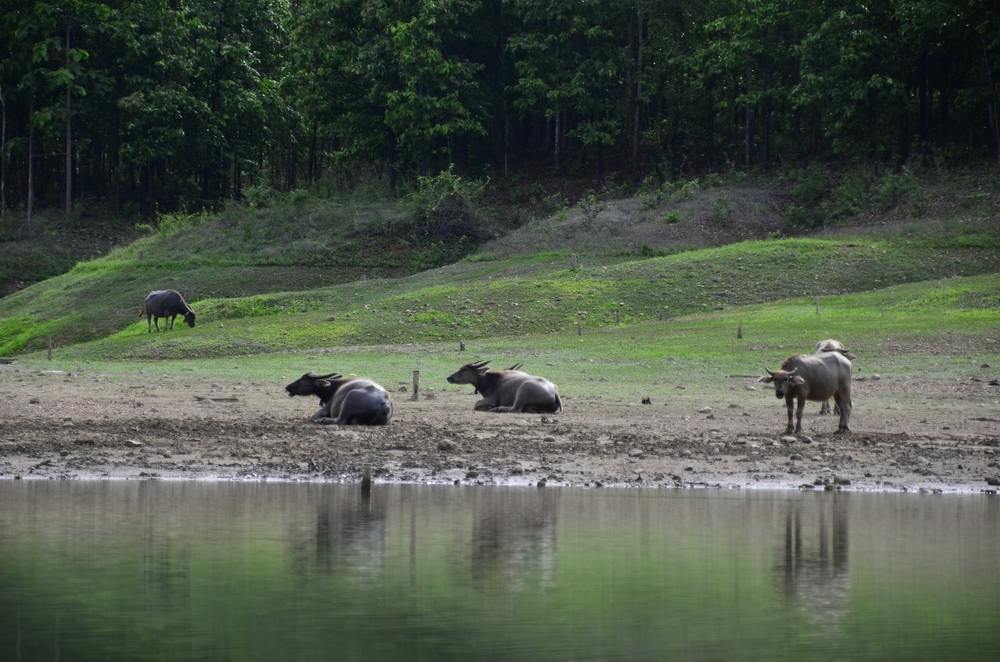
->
[0, 201, 469, 355]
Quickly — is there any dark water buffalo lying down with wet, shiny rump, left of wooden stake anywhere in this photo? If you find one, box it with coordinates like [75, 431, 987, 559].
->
[285, 372, 392, 425]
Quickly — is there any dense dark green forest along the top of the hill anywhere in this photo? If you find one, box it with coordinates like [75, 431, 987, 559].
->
[0, 0, 1000, 221]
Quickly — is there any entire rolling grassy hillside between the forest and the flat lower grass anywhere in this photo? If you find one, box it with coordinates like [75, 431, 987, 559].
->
[0, 169, 1000, 359]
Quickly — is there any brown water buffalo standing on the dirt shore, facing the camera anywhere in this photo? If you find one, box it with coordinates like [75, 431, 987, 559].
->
[760, 352, 851, 434]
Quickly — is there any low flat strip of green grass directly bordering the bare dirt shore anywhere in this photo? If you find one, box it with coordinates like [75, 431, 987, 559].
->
[21, 274, 1000, 399]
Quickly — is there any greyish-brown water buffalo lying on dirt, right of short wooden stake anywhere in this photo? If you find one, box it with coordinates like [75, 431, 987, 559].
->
[448, 361, 562, 414]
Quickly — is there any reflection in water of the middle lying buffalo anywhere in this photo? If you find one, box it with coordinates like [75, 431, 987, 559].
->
[469, 490, 559, 592]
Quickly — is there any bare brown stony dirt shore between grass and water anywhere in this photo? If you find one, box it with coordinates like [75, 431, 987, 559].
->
[0, 364, 1000, 492]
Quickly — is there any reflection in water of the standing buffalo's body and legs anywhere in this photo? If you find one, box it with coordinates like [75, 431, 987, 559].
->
[777, 493, 851, 632]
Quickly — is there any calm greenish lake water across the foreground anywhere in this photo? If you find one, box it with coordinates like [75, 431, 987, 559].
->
[0, 481, 1000, 661]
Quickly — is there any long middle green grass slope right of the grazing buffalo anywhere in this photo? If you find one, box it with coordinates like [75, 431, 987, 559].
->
[11, 239, 1000, 360]
